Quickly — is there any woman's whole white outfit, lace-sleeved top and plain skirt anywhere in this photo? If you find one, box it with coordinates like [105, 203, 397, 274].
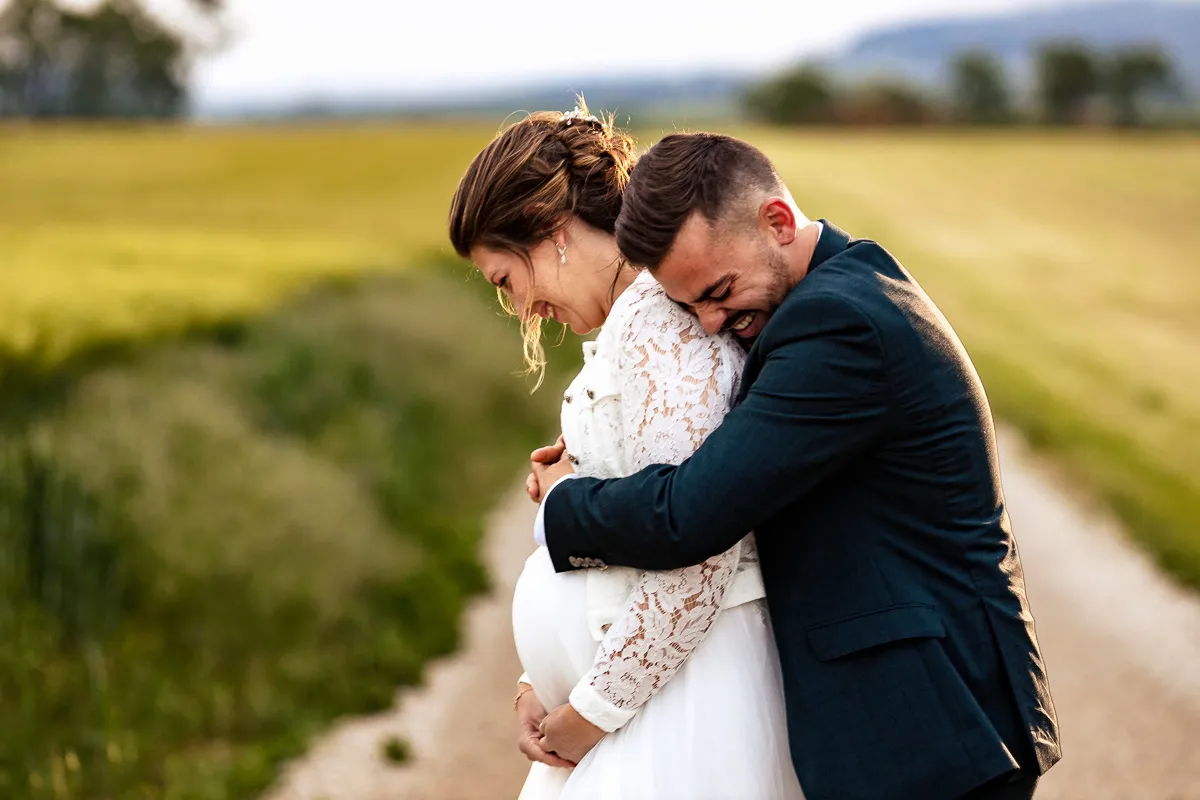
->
[512, 272, 803, 800]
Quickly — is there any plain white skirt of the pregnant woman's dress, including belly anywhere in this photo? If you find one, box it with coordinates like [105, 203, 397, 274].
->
[512, 547, 803, 800]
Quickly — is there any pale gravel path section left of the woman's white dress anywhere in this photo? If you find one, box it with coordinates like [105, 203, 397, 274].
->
[264, 487, 534, 800]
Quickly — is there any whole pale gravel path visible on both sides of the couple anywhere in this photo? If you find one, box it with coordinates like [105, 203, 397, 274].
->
[266, 432, 1200, 800]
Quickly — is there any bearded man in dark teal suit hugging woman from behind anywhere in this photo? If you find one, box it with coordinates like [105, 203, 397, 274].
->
[533, 133, 1061, 800]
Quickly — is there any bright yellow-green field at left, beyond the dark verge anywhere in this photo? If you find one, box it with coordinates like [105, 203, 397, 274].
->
[0, 127, 486, 376]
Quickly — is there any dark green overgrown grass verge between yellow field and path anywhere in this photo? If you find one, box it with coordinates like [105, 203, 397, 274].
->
[0, 266, 571, 800]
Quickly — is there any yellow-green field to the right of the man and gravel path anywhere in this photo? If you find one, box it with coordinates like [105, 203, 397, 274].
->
[750, 132, 1200, 587]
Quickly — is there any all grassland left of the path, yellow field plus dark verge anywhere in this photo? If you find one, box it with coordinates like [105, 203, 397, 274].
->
[0, 122, 576, 800]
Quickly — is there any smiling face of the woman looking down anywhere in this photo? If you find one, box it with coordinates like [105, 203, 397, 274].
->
[470, 240, 612, 335]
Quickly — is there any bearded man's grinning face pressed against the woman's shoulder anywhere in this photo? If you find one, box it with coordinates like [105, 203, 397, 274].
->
[654, 213, 792, 342]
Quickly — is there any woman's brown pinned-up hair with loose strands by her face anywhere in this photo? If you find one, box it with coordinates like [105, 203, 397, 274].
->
[450, 100, 636, 383]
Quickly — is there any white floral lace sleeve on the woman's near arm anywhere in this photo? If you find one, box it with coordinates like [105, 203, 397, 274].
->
[571, 295, 739, 732]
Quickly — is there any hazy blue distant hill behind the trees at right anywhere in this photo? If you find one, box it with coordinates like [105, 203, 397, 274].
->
[827, 0, 1200, 92]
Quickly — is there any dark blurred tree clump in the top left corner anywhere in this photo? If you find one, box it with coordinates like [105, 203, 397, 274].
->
[0, 0, 223, 118]
